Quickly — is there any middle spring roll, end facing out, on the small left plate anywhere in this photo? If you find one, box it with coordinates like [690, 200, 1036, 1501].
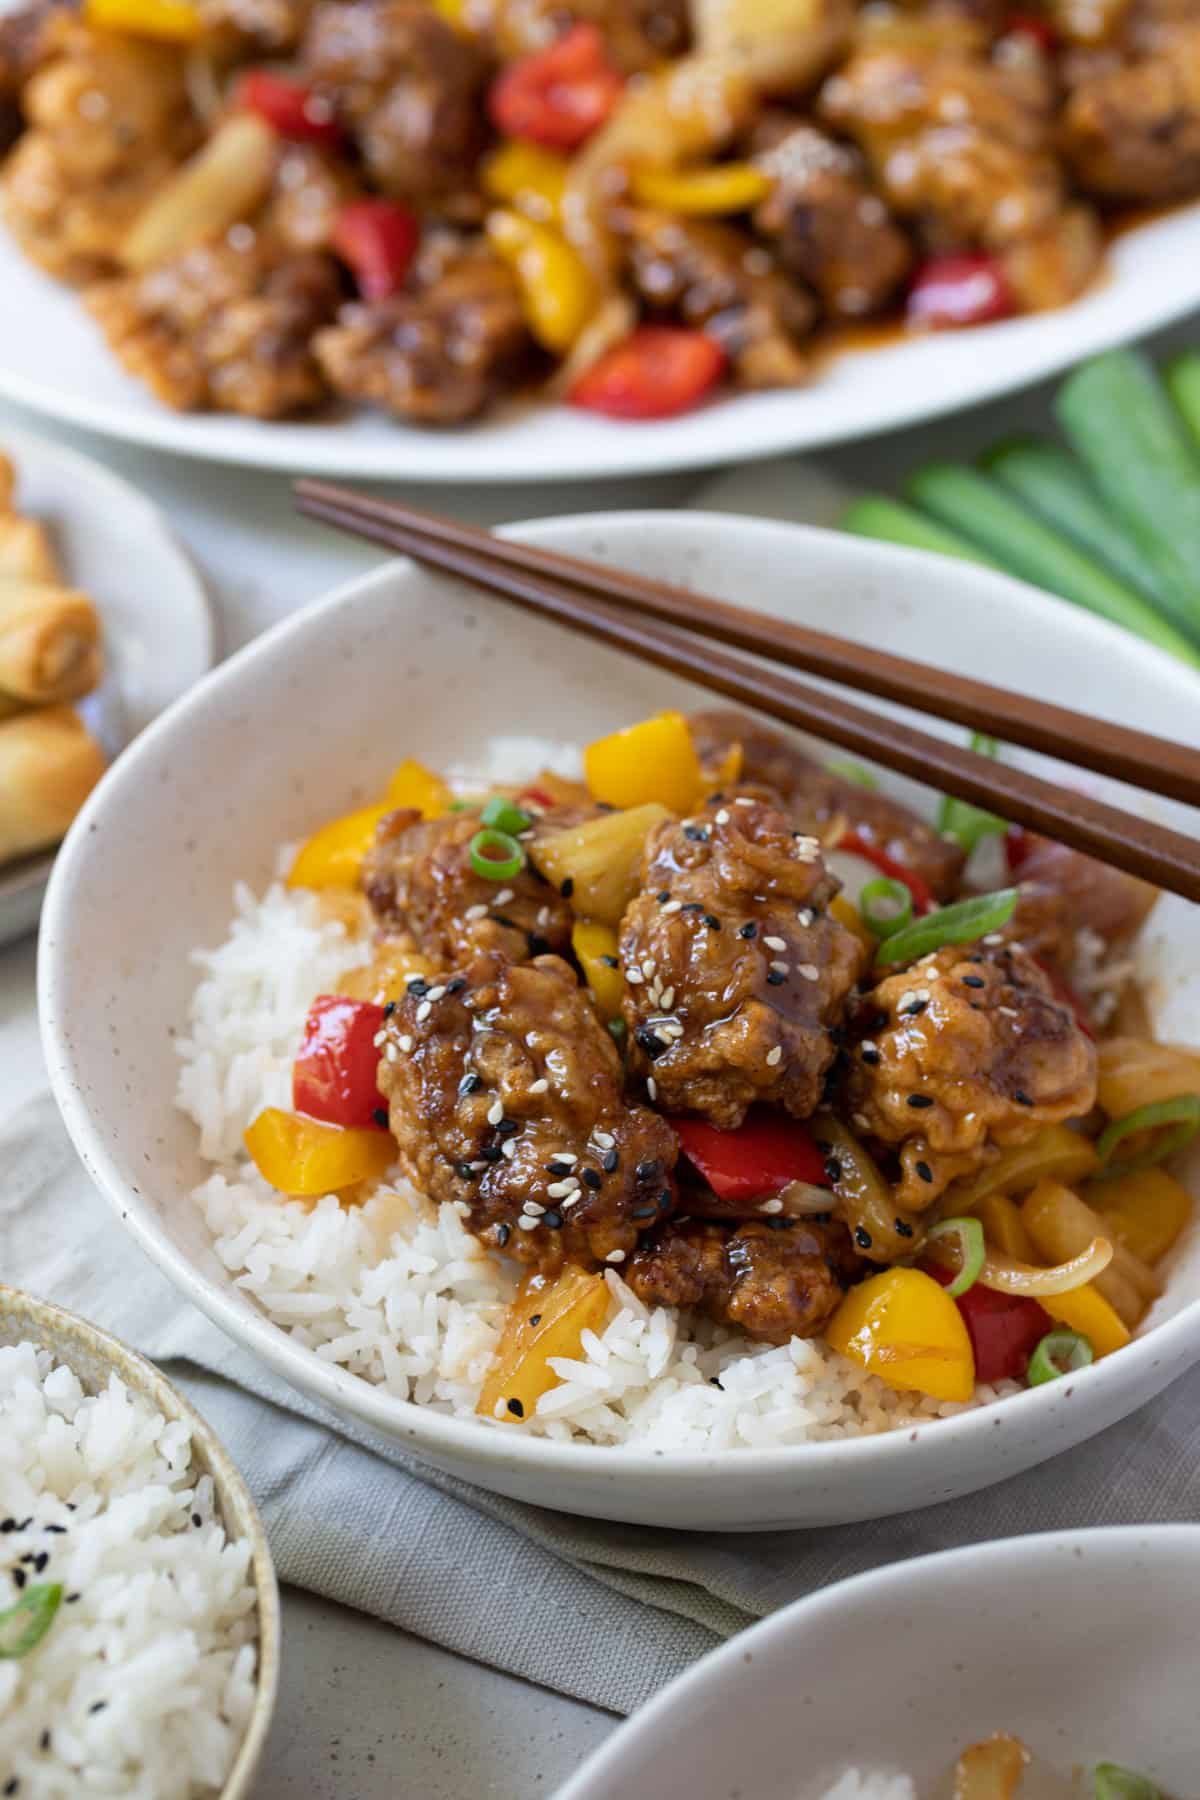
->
[0, 580, 101, 706]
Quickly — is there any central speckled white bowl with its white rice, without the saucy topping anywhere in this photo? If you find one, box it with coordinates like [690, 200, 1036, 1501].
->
[40, 513, 1200, 1530]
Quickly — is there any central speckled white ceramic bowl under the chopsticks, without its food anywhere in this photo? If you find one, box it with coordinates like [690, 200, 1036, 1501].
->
[40, 513, 1200, 1530]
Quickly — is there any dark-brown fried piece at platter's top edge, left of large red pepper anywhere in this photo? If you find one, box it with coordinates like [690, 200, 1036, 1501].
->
[302, 0, 488, 205]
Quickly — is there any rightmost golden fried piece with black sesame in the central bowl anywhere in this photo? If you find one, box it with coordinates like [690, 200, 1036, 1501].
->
[844, 941, 1096, 1211]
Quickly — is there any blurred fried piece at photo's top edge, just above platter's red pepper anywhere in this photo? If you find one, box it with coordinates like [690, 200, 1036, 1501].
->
[464, 0, 691, 76]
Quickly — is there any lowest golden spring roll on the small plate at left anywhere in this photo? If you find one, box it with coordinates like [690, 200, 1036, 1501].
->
[0, 706, 104, 862]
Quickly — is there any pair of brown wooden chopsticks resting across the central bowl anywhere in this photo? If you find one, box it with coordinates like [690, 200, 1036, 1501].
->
[295, 481, 1200, 900]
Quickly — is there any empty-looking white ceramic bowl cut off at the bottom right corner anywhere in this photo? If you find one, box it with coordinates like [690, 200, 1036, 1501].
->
[556, 1525, 1200, 1800]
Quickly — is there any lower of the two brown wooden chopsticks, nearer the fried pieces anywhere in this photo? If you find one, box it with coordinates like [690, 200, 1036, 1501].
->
[297, 482, 1200, 900]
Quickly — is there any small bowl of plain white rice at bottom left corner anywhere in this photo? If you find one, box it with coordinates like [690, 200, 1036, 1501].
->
[0, 1287, 279, 1800]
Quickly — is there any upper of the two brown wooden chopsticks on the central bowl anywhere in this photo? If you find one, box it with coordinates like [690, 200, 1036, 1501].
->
[295, 481, 1200, 806]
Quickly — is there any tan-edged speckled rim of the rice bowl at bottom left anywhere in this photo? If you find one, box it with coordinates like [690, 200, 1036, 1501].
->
[0, 1282, 281, 1800]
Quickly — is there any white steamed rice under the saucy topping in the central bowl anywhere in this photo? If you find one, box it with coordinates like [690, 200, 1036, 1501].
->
[170, 884, 1015, 1451]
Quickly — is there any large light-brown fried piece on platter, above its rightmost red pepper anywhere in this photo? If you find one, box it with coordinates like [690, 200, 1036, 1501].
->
[819, 47, 1063, 250]
